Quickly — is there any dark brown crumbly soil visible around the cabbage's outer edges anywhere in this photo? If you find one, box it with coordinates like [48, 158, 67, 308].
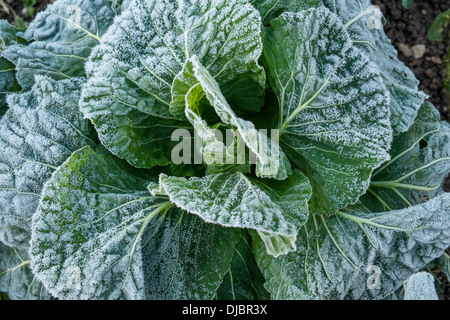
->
[0, 0, 450, 300]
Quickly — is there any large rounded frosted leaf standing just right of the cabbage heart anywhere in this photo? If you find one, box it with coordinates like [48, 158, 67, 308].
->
[263, 8, 392, 213]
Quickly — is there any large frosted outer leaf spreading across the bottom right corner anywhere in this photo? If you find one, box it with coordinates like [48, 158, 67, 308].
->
[254, 194, 450, 299]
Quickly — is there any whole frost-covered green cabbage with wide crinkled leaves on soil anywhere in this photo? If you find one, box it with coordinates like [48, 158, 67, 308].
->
[0, 0, 450, 300]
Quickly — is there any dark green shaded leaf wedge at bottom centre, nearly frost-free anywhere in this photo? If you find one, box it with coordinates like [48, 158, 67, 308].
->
[217, 231, 270, 300]
